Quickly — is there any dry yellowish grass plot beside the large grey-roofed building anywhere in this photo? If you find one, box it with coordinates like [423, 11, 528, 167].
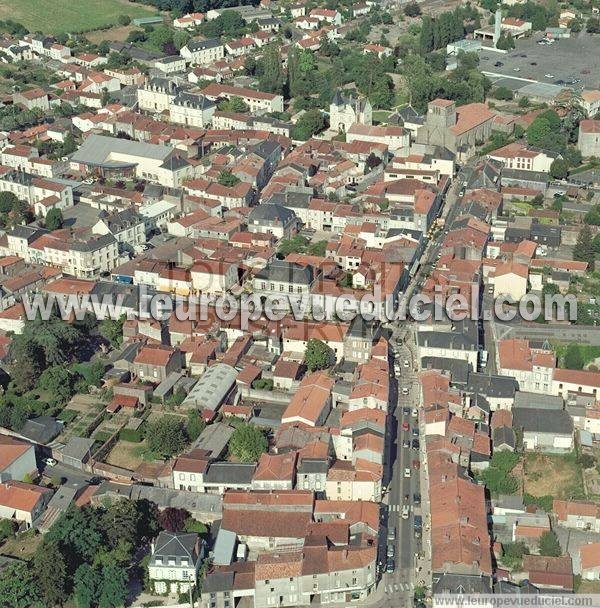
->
[524, 452, 585, 499]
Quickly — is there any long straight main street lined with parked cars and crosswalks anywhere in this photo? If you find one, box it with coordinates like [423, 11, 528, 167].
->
[378, 159, 472, 607]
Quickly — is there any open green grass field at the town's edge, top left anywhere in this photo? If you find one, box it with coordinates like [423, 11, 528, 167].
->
[0, 0, 155, 34]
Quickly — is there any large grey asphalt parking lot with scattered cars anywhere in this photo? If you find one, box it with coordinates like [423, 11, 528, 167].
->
[479, 32, 600, 90]
